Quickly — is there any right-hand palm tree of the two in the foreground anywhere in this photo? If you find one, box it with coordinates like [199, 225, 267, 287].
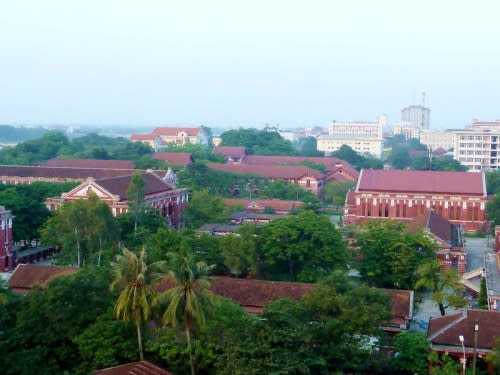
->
[161, 249, 214, 375]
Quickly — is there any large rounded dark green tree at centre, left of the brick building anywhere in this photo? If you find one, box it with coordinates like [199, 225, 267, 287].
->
[258, 211, 347, 281]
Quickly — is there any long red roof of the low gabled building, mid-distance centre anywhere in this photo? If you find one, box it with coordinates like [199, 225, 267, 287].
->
[207, 163, 324, 180]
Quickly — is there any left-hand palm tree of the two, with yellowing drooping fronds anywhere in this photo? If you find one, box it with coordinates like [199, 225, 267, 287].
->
[110, 248, 164, 360]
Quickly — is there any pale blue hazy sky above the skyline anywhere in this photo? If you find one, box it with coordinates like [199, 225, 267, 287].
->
[0, 0, 500, 129]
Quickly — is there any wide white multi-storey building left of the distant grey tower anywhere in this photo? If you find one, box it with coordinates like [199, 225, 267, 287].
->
[317, 116, 387, 158]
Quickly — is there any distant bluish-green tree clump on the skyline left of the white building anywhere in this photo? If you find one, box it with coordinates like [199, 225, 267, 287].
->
[220, 128, 294, 155]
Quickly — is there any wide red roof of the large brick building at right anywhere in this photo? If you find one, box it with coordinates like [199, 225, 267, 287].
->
[358, 169, 486, 196]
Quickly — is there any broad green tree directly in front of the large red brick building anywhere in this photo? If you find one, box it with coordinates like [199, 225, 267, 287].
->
[356, 220, 436, 289]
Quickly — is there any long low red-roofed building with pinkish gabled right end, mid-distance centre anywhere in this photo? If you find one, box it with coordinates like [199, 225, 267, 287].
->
[207, 163, 325, 195]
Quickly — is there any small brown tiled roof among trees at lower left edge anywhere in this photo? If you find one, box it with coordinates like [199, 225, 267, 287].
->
[8, 264, 78, 291]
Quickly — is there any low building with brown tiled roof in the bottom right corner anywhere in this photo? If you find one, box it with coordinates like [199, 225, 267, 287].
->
[427, 310, 500, 367]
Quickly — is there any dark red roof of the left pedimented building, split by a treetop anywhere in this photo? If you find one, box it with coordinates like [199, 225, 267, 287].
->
[95, 173, 173, 201]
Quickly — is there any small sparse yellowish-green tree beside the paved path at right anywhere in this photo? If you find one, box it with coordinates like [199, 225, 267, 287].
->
[415, 259, 467, 316]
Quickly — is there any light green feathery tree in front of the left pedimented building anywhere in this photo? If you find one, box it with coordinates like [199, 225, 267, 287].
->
[41, 193, 119, 266]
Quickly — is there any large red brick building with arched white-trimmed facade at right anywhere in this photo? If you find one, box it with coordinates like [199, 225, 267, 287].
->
[344, 169, 487, 232]
